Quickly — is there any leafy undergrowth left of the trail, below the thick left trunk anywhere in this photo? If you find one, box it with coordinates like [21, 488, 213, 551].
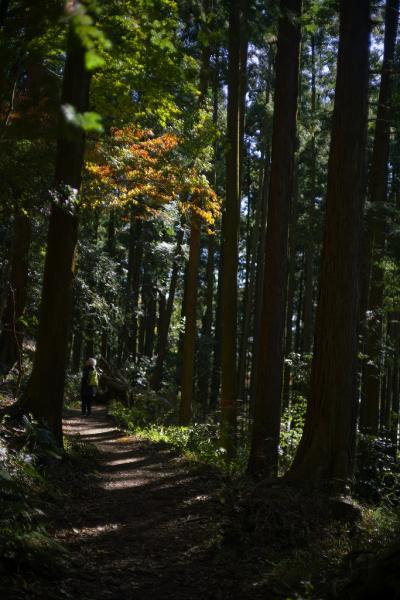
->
[0, 406, 96, 581]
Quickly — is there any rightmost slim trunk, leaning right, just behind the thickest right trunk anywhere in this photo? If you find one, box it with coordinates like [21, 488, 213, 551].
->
[360, 0, 399, 434]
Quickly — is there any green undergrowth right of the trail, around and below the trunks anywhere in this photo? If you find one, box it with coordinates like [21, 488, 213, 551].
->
[109, 394, 400, 600]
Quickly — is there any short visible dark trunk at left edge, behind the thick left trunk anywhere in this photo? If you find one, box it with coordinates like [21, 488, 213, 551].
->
[0, 210, 31, 373]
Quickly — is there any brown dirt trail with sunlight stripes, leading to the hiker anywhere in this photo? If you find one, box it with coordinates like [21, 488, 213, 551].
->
[48, 408, 228, 600]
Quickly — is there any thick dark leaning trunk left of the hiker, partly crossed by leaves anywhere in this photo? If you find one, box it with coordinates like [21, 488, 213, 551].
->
[23, 19, 89, 446]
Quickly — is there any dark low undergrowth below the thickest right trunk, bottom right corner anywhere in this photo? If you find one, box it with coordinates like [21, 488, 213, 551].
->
[220, 478, 400, 600]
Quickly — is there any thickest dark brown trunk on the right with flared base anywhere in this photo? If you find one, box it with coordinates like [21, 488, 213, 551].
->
[288, 0, 370, 489]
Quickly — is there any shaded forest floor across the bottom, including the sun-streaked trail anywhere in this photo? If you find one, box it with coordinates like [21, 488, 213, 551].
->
[0, 407, 400, 600]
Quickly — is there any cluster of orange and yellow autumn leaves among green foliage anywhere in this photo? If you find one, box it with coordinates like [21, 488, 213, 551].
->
[86, 125, 220, 227]
